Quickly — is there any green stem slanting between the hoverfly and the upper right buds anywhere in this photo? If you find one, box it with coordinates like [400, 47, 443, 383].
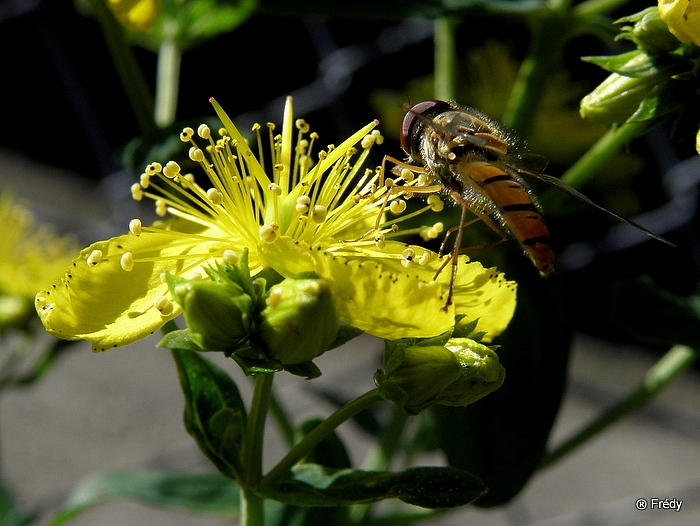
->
[561, 122, 646, 188]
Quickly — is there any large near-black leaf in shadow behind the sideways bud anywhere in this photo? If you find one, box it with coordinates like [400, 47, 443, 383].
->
[430, 262, 571, 507]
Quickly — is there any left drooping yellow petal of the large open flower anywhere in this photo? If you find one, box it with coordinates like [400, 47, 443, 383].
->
[35, 232, 227, 351]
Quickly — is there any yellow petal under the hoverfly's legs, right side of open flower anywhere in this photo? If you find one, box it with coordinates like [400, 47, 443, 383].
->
[258, 237, 515, 341]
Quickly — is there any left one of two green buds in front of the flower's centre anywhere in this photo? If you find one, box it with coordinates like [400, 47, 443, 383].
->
[168, 276, 253, 351]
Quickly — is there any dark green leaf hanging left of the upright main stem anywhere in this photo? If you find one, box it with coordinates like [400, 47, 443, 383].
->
[172, 349, 247, 478]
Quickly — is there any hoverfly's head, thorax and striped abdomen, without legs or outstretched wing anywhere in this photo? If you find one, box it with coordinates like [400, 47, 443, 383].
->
[403, 101, 555, 276]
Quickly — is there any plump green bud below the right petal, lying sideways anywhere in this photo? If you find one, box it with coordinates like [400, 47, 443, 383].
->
[374, 338, 505, 414]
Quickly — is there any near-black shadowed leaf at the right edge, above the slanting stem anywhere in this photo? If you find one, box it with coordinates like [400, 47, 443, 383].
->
[612, 277, 700, 349]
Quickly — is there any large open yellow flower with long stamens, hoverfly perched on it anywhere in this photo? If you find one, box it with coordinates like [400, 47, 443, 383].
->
[36, 98, 515, 351]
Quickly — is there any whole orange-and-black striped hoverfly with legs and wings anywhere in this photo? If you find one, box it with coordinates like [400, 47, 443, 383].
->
[382, 100, 672, 308]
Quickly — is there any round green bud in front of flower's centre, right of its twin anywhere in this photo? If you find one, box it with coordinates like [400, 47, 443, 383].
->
[256, 279, 340, 365]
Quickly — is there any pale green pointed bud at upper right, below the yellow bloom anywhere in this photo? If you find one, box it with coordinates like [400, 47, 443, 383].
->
[580, 52, 676, 124]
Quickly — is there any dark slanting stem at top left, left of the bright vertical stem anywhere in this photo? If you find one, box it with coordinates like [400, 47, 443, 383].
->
[90, 0, 156, 135]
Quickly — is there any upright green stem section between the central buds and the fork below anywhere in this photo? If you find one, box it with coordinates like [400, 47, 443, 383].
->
[241, 373, 275, 488]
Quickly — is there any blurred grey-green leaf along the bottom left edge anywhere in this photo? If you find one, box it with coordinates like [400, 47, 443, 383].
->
[46, 471, 239, 526]
